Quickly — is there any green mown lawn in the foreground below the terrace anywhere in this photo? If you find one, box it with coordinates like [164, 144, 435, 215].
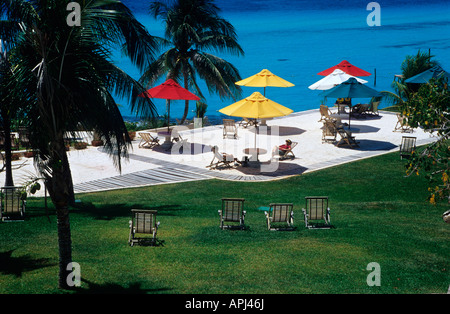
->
[0, 153, 450, 294]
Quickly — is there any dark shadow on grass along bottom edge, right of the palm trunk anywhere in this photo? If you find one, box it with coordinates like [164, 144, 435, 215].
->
[75, 278, 172, 294]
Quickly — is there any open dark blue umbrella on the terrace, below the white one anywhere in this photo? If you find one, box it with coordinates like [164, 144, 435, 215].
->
[319, 77, 382, 128]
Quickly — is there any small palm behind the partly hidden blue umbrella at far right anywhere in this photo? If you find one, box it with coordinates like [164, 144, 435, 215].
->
[382, 50, 438, 107]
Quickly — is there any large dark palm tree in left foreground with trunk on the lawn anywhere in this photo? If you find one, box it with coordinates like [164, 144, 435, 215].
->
[0, 0, 156, 288]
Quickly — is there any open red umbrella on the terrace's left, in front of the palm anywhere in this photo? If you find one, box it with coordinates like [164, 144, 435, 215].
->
[139, 79, 200, 131]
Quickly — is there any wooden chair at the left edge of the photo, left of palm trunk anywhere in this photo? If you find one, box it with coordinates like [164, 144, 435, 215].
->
[0, 186, 26, 221]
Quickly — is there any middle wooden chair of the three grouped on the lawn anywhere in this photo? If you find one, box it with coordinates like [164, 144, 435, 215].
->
[264, 203, 295, 230]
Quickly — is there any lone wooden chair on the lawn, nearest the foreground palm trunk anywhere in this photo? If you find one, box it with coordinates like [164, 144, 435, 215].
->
[128, 209, 160, 246]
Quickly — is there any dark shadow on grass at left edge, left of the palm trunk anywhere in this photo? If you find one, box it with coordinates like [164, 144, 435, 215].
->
[0, 250, 56, 277]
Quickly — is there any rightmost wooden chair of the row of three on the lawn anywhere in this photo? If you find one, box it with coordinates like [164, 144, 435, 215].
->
[302, 196, 331, 229]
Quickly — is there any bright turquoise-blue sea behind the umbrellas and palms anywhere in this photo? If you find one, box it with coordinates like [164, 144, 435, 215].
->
[117, 0, 450, 120]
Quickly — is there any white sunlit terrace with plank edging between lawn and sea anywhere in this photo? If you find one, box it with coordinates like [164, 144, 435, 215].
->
[0, 110, 435, 196]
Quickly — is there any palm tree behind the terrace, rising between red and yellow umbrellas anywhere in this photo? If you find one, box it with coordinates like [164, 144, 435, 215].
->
[141, 0, 244, 123]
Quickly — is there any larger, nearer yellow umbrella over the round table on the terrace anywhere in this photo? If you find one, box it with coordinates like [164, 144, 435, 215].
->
[219, 92, 294, 157]
